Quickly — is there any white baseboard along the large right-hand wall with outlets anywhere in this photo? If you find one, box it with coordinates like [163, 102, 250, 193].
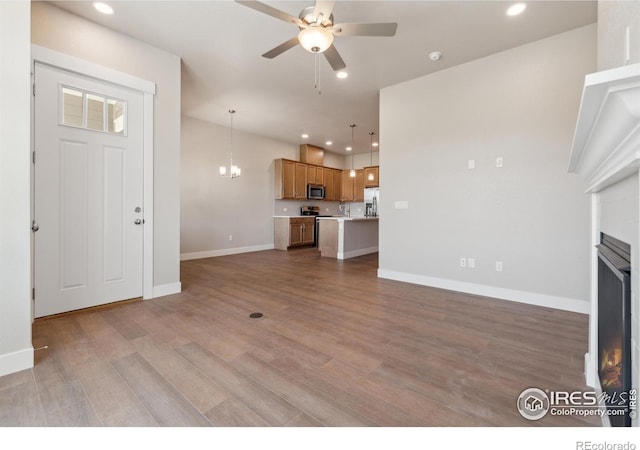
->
[378, 269, 589, 314]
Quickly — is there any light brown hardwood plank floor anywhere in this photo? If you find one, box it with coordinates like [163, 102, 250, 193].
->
[0, 249, 599, 427]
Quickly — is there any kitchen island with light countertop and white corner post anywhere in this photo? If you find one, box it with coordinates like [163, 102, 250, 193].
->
[317, 216, 378, 259]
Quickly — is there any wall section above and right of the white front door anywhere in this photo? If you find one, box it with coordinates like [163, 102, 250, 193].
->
[31, 2, 180, 286]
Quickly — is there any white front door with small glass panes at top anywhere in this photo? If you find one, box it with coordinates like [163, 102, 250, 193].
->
[34, 63, 144, 317]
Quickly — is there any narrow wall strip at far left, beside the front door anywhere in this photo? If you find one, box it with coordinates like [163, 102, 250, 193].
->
[0, 2, 33, 376]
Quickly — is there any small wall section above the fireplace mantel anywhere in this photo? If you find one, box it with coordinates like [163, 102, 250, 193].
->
[598, 0, 640, 70]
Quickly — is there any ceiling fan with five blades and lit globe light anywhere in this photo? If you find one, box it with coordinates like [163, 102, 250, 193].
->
[236, 0, 398, 71]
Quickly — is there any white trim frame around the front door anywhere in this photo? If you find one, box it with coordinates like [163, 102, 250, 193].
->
[31, 45, 156, 300]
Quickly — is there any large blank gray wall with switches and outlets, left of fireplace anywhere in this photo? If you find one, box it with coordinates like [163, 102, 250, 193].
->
[379, 25, 596, 312]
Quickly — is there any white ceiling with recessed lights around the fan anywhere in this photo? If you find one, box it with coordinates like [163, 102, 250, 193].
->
[48, 0, 597, 153]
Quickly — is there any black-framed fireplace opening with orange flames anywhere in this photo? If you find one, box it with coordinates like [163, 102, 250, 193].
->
[597, 233, 631, 427]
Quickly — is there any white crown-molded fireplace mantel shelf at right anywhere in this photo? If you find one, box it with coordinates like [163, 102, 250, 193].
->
[569, 63, 640, 192]
